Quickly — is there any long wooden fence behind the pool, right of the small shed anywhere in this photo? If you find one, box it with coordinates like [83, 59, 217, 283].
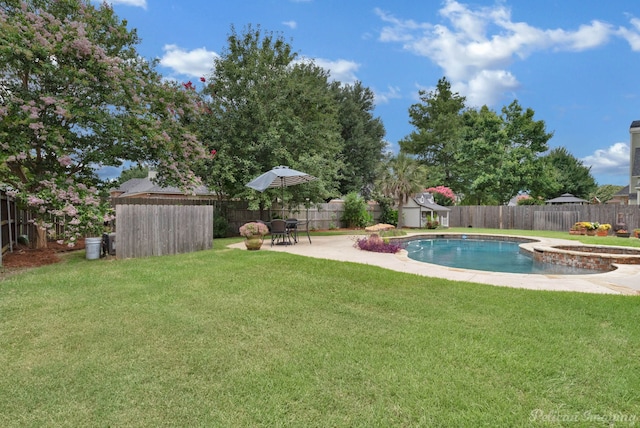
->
[449, 204, 640, 231]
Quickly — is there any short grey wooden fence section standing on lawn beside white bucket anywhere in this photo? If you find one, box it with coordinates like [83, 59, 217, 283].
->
[115, 200, 213, 258]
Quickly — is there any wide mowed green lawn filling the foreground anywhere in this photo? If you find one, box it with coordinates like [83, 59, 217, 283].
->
[0, 235, 640, 427]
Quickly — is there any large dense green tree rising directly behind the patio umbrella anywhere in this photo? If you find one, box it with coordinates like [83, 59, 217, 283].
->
[201, 26, 343, 210]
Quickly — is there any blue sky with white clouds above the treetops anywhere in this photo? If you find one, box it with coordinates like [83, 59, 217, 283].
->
[102, 0, 640, 185]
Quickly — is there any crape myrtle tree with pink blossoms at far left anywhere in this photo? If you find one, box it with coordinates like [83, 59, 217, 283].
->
[0, 0, 208, 246]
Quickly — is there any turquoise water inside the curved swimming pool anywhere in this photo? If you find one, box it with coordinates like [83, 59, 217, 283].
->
[405, 238, 601, 275]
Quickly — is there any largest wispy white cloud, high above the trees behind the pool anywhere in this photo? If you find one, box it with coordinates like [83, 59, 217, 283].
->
[375, 0, 616, 105]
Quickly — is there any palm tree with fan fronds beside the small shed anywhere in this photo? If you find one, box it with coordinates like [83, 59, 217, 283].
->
[379, 152, 427, 229]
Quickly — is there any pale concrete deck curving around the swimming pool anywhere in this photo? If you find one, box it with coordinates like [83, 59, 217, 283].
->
[230, 233, 640, 295]
